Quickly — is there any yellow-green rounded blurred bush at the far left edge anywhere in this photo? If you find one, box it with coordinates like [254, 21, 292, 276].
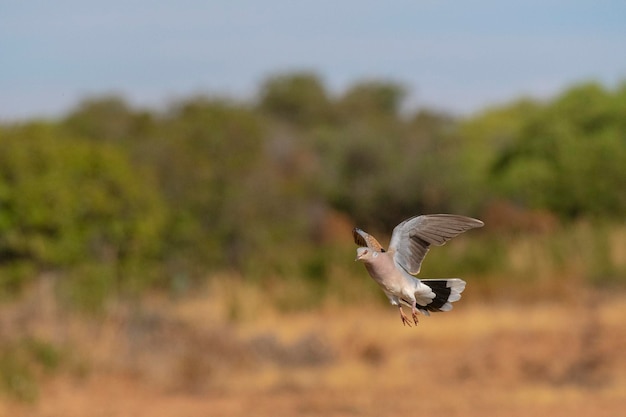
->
[0, 124, 165, 300]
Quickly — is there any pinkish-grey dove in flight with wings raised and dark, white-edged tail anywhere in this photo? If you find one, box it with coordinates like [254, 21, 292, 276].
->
[352, 214, 484, 327]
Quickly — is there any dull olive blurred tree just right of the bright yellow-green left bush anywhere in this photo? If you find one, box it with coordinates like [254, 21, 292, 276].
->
[156, 98, 262, 272]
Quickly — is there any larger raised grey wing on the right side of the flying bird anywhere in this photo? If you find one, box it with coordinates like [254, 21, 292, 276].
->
[390, 214, 484, 275]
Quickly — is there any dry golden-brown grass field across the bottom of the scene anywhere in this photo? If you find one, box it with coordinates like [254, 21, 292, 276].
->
[0, 284, 626, 417]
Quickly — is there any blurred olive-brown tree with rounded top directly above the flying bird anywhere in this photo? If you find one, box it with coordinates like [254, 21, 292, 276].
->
[314, 82, 454, 230]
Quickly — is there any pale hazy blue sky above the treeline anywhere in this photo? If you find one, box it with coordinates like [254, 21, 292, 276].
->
[0, 0, 626, 120]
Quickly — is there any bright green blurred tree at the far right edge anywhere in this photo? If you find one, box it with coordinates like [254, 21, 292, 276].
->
[470, 80, 626, 219]
